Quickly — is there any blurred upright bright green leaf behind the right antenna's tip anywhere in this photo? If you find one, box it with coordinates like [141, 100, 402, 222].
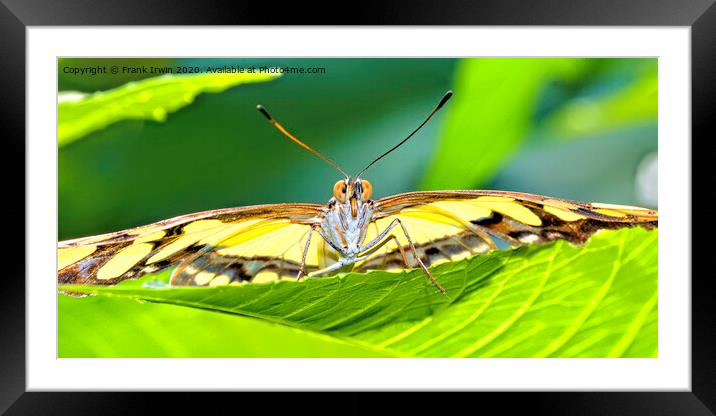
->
[422, 58, 588, 189]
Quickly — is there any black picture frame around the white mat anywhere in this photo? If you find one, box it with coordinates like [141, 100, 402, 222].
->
[0, 0, 704, 415]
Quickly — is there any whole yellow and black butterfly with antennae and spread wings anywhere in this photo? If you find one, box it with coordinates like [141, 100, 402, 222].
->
[58, 91, 658, 294]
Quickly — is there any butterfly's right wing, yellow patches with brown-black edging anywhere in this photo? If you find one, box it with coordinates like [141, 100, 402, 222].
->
[358, 191, 658, 270]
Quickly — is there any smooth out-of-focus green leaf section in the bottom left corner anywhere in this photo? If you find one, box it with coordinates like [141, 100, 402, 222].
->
[58, 295, 386, 358]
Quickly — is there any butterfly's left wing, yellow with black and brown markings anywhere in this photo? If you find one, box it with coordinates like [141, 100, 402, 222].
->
[58, 204, 324, 286]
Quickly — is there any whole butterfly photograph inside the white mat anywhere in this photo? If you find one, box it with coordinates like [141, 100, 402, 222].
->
[58, 56, 656, 362]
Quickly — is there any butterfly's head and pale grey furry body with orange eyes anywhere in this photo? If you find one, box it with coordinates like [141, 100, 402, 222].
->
[321, 179, 373, 259]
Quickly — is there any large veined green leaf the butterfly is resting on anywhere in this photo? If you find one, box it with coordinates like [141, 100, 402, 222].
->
[60, 229, 658, 357]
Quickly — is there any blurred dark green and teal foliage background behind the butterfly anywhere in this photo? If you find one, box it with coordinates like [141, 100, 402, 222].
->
[58, 58, 657, 239]
